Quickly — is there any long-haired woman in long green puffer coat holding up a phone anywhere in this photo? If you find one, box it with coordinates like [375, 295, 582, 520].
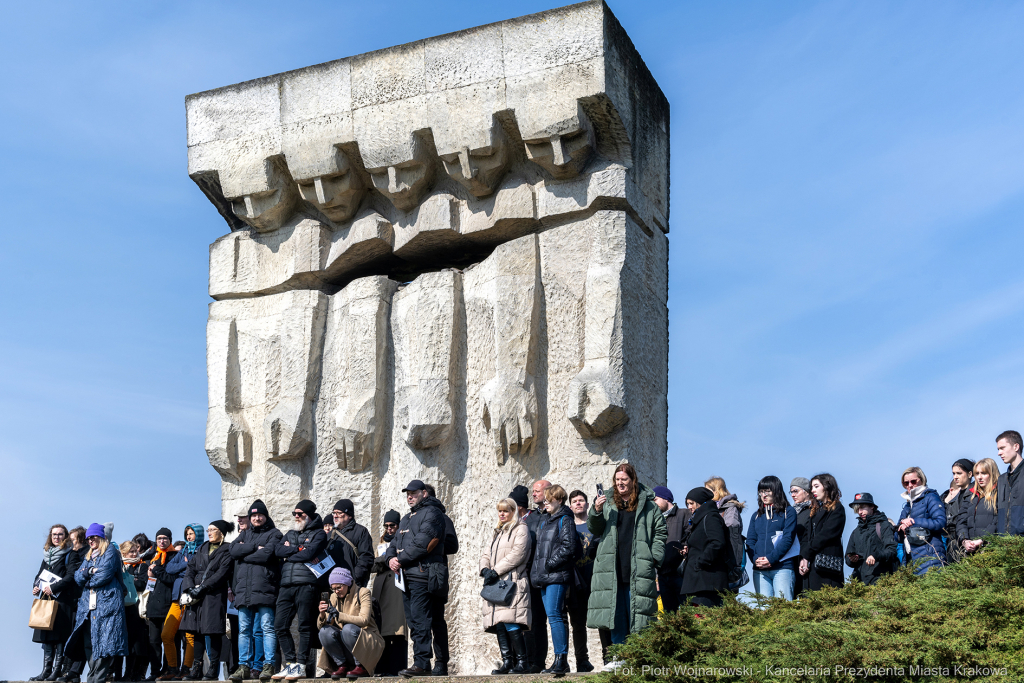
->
[587, 463, 668, 659]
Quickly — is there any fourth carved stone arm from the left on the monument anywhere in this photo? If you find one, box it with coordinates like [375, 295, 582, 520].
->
[392, 270, 462, 450]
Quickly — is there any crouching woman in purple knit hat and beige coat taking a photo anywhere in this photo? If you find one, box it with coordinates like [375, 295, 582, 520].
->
[316, 567, 384, 680]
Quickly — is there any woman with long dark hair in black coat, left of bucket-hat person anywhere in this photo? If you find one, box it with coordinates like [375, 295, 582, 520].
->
[800, 473, 846, 591]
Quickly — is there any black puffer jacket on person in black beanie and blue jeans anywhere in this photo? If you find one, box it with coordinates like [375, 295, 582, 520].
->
[228, 517, 283, 607]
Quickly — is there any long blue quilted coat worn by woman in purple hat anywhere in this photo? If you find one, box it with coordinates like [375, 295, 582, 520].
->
[65, 544, 128, 660]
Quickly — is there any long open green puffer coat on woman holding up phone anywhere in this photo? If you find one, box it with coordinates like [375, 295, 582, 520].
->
[587, 483, 668, 633]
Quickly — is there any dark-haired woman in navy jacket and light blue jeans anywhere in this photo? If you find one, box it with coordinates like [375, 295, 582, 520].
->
[745, 475, 800, 600]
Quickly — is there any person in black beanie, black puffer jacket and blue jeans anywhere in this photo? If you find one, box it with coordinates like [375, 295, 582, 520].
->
[228, 500, 282, 683]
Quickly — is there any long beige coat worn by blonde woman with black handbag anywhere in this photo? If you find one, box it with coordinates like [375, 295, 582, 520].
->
[480, 521, 532, 633]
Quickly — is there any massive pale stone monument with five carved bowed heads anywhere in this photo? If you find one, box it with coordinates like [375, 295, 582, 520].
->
[191, 2, 669, 674]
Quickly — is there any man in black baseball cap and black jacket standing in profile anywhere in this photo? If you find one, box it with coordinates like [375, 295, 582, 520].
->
[387, 479, 449, 678]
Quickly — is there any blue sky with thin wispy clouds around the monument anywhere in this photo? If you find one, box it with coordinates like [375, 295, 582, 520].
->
[0, 1, 1024, 680]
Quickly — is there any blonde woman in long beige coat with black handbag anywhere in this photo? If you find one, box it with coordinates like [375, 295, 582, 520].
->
[480, 498, 532, 675]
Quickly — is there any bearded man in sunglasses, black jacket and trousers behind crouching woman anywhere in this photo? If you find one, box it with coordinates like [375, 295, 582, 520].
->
[272, 501, 327, 681]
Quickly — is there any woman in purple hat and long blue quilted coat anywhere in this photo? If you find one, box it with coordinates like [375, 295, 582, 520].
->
[65, 524, 128, 683]
